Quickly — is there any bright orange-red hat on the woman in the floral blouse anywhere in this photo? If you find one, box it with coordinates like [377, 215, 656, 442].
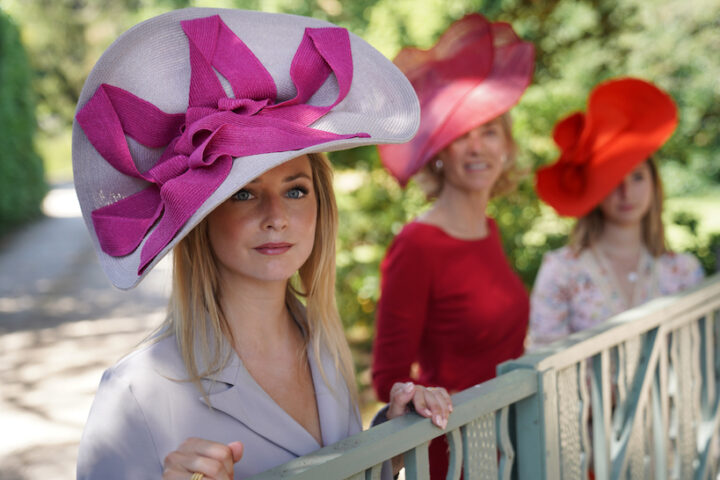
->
[536, 78, 677, 217]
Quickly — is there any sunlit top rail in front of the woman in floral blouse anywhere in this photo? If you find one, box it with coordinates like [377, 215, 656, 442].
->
[506, 274, 720, 371]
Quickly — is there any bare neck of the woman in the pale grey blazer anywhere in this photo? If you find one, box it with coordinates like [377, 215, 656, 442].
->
[220, 279, 299, 358]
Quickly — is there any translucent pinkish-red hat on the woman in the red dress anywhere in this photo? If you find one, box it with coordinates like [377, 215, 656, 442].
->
[378, 14, 535, 186]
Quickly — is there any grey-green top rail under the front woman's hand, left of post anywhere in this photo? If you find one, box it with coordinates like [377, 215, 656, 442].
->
[251, 370, 537, 480]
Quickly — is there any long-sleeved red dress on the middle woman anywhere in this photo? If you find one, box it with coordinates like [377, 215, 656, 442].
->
[372, 218, 529, 479]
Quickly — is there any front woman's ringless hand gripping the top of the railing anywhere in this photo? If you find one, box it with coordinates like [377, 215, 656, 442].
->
[387, 382, 452, 428]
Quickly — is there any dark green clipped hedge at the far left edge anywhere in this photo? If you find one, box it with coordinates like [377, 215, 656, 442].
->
[0, 10, 46, 234]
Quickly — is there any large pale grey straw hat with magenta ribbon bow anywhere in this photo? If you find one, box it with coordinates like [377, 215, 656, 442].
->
[72, 8, 419, 289]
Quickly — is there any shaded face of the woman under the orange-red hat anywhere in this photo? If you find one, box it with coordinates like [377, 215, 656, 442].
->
[600, 162, 653, 225]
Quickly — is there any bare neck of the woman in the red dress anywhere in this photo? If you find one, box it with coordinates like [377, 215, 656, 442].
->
[427, 183, 490, 238]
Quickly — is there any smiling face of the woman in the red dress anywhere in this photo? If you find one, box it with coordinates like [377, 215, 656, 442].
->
[438, 117, 509, 192]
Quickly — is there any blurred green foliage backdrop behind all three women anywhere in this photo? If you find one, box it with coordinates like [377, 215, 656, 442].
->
[0, 0, 720, 472]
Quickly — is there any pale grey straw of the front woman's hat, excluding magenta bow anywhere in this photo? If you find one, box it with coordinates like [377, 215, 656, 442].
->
[73, 8, 419, 289]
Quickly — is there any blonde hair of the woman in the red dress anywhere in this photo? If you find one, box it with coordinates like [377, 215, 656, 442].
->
[415, 111, 524, 200]
